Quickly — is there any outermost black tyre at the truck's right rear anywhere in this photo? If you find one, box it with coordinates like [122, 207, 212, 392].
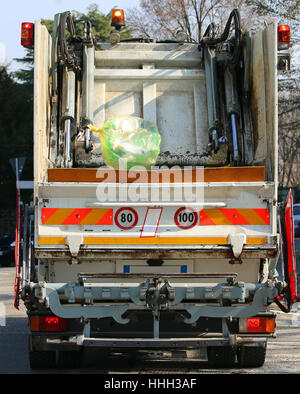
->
[237, 344, 267, 368]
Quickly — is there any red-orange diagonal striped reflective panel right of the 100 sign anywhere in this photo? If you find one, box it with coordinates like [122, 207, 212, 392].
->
[200, 208, 270, 226]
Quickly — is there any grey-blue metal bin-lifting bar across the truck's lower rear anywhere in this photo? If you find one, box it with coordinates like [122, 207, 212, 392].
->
[32, 273, 278, 324]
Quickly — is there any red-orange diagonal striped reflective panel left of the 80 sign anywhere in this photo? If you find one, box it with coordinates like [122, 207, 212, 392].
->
[42, 208, 113, 225]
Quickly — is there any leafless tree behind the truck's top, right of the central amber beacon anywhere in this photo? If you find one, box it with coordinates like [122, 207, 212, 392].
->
[128, 0, 270, 42]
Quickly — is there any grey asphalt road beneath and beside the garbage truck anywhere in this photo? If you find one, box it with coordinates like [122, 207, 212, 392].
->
[0, 268, 300, 375]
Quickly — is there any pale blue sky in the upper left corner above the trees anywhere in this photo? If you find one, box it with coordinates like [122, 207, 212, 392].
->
[0, 0, 139, 71]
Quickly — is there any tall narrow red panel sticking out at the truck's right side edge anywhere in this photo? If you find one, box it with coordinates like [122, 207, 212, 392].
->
[275, 189, 297, 313]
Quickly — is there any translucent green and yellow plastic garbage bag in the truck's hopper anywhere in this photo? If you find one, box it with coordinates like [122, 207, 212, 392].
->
[89, 116, 161, 170]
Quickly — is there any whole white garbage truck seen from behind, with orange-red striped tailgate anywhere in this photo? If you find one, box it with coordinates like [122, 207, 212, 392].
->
[15, 9, 297, 369]
